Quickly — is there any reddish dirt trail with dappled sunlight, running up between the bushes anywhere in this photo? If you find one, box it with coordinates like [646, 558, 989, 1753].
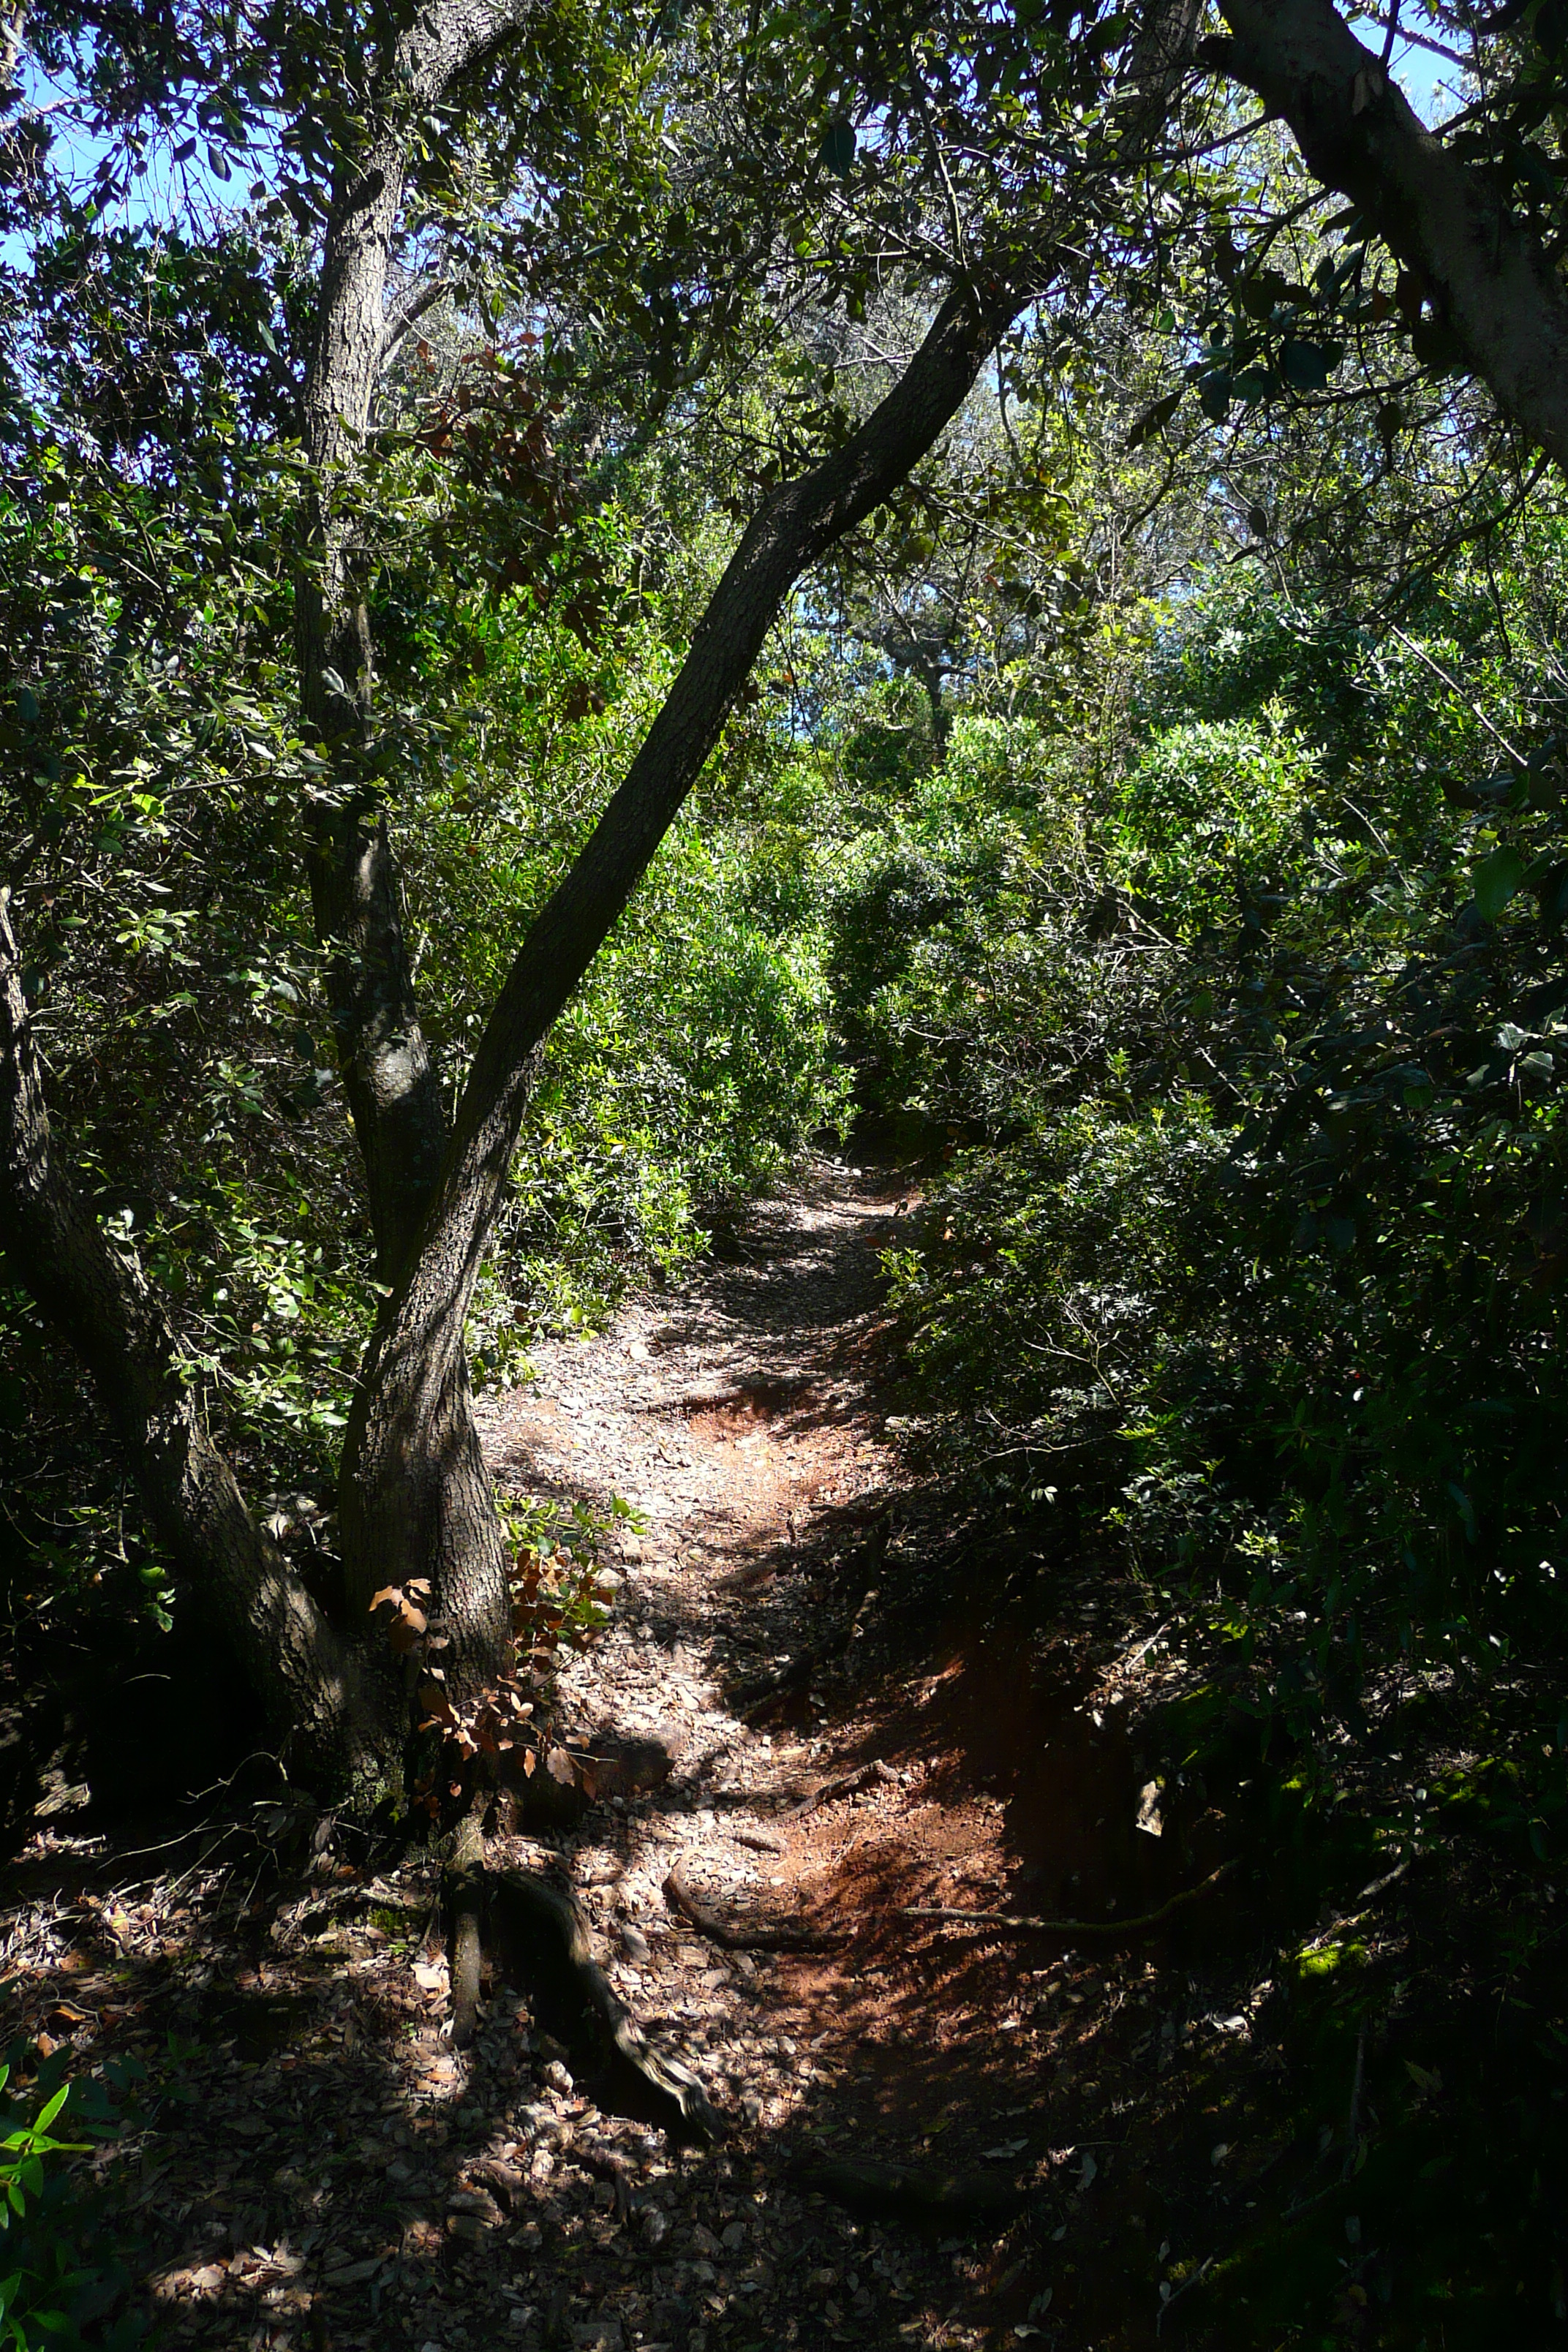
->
[456, 1162, 1251, 2352]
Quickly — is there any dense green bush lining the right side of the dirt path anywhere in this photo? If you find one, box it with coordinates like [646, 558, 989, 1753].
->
[872, 534, 1568, 1778]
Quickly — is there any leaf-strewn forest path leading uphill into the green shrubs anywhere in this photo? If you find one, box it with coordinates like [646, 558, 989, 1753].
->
[451, 1162, 1128, 2352]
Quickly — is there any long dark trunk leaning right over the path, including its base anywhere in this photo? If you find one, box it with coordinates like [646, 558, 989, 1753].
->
[339, 290, 1022, 1698]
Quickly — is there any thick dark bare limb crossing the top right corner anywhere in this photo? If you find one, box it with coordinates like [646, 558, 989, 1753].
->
[1204, 0, 1568, 466]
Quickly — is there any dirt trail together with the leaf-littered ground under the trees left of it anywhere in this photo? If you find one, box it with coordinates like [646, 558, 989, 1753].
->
[0, 1162, 1237, 2352]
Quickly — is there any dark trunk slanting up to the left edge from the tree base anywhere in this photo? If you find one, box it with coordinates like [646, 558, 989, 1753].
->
[0, 894, 402, 1787]
